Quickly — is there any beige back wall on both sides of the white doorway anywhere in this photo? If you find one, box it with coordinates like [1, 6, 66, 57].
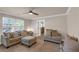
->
[32, 15, 67, 36]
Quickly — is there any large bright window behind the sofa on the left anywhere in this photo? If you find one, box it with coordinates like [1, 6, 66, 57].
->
[3, 17, 24, 32]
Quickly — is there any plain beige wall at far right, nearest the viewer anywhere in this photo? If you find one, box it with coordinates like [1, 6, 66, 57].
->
[67, 7, 79, 38]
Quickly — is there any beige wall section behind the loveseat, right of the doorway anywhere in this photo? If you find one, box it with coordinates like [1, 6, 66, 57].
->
[45, 15, 67, 34]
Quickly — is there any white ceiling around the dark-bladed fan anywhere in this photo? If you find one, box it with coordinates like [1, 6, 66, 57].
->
[0, 7, 68, 19]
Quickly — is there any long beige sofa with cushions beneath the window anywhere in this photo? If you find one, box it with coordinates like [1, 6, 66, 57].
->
[1, 30, 33, 48]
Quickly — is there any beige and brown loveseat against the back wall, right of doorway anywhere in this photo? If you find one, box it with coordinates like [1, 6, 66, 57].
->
[44, 29, 62, 43]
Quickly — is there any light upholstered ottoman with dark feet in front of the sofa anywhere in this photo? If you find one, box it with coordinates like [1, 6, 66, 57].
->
[21, 36, 36, 47]
